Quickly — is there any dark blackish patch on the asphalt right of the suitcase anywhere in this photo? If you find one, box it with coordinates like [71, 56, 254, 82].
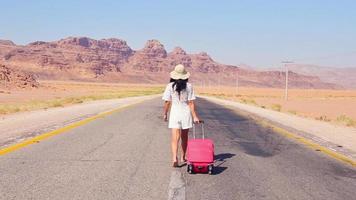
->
[199, 99, 286, 157]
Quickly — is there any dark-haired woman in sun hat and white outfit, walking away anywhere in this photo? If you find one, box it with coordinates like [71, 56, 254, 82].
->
[162, 64, 200, 167]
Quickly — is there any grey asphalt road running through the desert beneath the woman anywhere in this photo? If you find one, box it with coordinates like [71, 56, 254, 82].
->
[0, 99, 356, 200]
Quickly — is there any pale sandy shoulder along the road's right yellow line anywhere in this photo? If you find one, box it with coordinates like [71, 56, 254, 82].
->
[200, 96, 356, 159]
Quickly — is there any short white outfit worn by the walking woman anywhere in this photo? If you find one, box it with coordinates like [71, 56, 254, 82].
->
[162, 83, 196, 129]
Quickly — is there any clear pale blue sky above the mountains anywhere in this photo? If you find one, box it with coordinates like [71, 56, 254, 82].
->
[0, 0, 356, 67]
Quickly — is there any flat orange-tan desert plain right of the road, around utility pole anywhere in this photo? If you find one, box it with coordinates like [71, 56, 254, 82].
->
[197, 86, 356, 126]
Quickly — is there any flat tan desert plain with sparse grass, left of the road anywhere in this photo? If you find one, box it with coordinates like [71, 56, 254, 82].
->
[0, 80, 163, 115]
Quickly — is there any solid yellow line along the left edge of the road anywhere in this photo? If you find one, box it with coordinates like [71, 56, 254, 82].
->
[0, 100, 145, 156]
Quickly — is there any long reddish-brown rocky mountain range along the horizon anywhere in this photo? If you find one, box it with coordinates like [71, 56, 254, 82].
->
[0, 37, 339, 88]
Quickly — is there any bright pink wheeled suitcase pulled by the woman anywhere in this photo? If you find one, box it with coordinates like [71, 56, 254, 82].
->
[187, 121, 214, 174]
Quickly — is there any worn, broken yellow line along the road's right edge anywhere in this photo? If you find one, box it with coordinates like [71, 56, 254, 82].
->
[224, 105, 356, 167]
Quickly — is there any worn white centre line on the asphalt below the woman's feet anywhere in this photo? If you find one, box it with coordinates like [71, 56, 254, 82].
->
[168, 170, 185, 200]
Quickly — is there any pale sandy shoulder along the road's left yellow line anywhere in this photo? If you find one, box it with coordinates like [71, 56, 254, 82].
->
[0, 95, 158, 147]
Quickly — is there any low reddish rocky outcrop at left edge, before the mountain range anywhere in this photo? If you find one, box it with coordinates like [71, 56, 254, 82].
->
[0, 65, 39, 88]
